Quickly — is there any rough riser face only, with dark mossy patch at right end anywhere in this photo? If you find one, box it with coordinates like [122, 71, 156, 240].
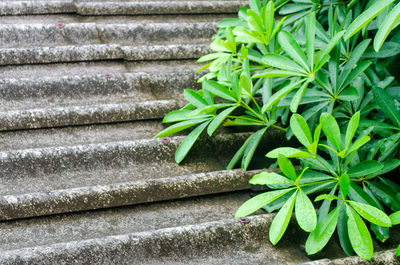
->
[0, 71, 199, 101]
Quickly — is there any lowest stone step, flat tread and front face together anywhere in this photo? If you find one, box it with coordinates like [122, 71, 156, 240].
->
[0, 192, 312, 264]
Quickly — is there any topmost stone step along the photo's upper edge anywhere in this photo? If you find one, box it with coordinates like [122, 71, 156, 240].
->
[0, 0, 248, 16]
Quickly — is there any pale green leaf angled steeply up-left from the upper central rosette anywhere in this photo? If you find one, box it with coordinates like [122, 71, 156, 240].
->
[278, 30, 310, 73]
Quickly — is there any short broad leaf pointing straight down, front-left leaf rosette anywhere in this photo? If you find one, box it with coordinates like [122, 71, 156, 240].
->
[295, 189, 317, 232]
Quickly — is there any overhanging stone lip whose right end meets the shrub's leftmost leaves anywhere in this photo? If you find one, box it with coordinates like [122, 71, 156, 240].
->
[0, 100, 181, 131]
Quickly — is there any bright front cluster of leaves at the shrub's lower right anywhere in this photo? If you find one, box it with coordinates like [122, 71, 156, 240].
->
[236, 112, 400, 259]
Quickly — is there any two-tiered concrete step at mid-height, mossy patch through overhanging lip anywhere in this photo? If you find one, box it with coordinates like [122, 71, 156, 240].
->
[0, 61, 199, 130]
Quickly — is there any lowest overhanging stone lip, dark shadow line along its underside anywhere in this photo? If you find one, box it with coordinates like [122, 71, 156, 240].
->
[0, 170, 258, 220]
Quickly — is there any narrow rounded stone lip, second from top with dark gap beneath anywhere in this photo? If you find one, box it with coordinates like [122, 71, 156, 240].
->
[0, 44, 210, 65]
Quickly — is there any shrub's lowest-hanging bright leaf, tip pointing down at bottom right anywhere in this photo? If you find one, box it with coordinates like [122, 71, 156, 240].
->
[346, 205, 374, 260]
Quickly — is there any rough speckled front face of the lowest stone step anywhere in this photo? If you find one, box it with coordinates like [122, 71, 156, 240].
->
[0, 212, 308, 265]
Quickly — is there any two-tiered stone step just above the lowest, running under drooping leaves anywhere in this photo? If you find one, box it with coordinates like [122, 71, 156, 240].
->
[0, 121, 283, 220]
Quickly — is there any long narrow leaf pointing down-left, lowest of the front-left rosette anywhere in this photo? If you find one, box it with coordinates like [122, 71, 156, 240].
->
[269, 192, 297, 245]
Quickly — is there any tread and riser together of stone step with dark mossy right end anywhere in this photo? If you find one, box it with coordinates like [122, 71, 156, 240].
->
[0, 61, 201, 100]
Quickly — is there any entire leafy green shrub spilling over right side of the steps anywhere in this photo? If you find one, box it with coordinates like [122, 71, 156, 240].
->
[157, 0, 400, 259]
